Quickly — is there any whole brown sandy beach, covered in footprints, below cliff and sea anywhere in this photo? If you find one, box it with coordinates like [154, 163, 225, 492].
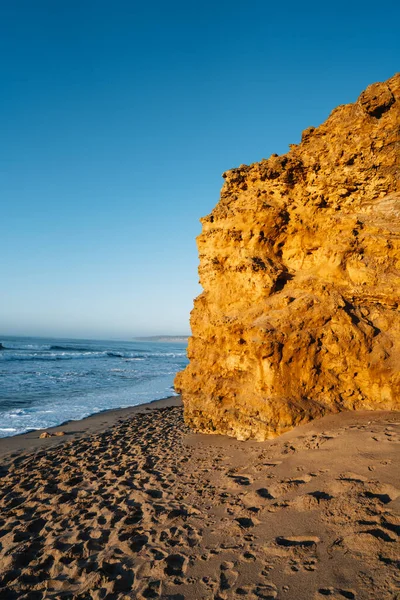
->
[0, 399, 400, 600]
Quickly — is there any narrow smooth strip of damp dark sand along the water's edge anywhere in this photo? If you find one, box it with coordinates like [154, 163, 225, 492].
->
[0, 396, 182, 460]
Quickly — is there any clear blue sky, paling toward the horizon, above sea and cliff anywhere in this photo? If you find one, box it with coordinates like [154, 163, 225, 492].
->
[0, 0, 400, 339]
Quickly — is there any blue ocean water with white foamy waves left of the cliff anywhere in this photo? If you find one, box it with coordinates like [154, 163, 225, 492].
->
[0, 337, 188, 437]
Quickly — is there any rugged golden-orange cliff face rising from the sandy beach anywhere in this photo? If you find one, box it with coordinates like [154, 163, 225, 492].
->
[175, 74, 400, 440]
